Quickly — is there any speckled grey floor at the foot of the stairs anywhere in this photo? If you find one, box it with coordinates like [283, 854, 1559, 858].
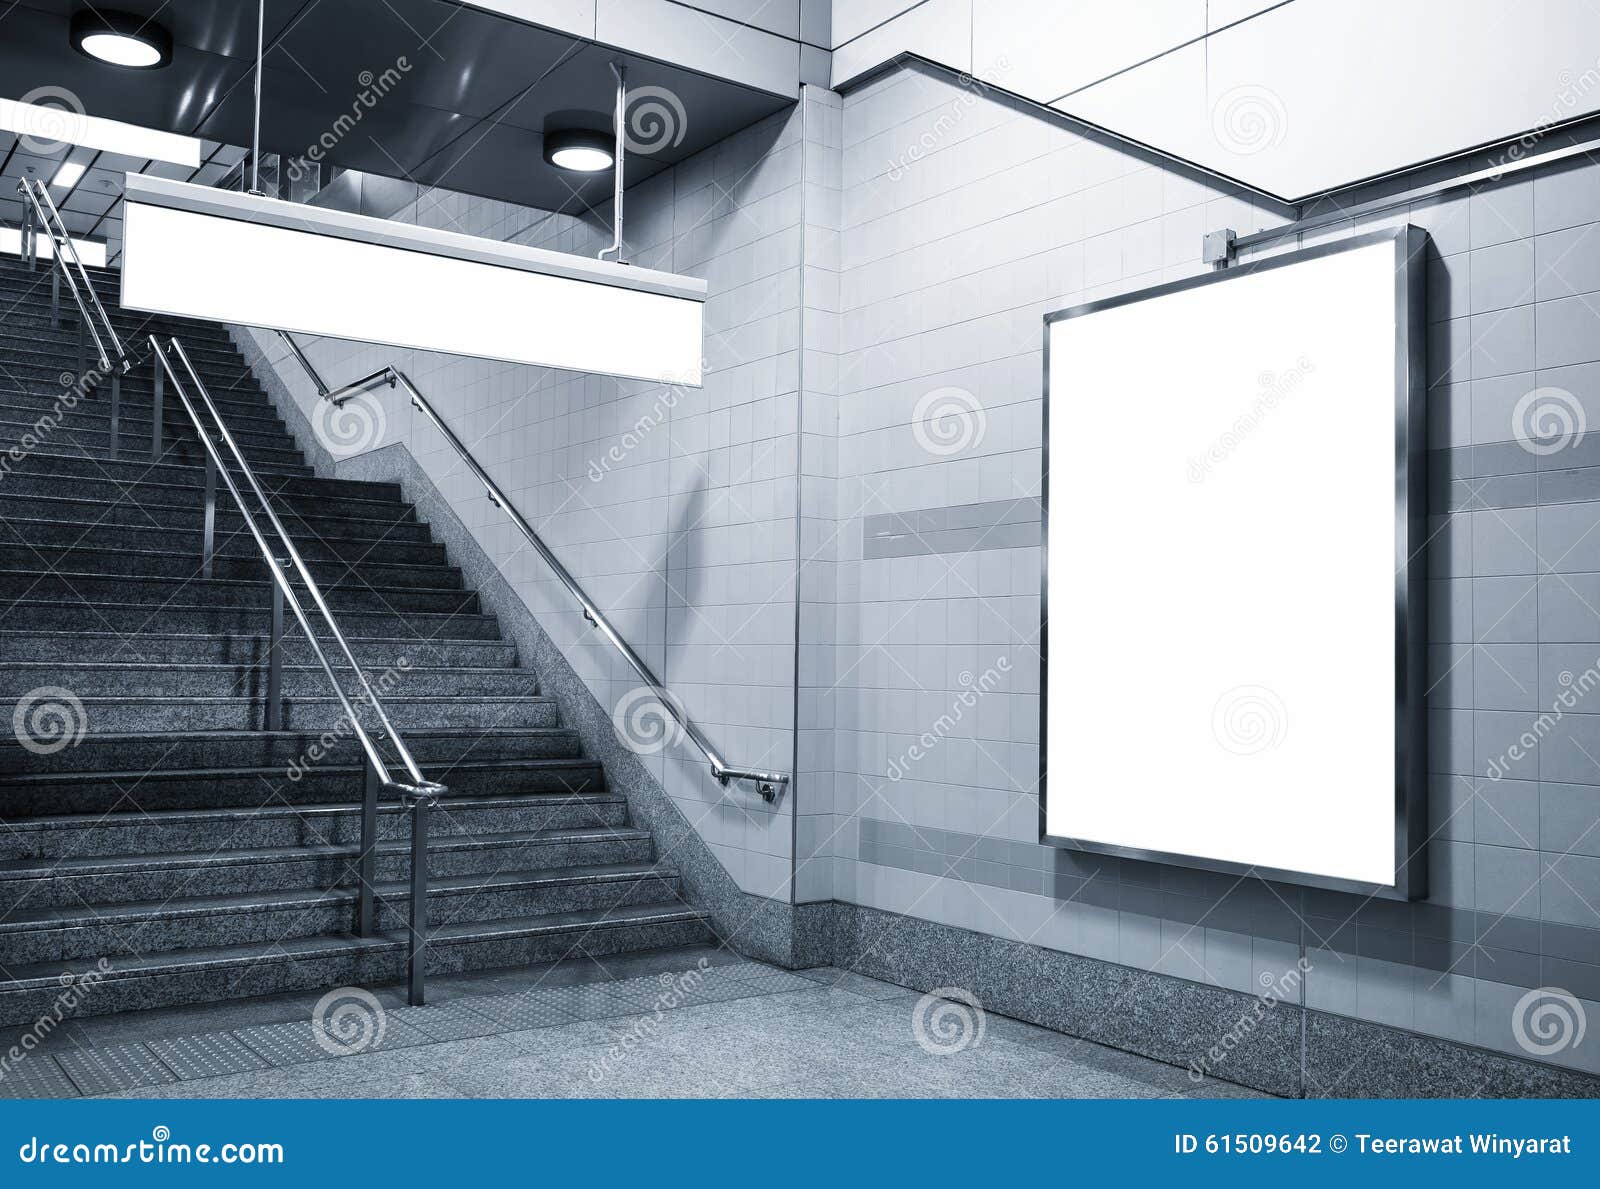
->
[0, 947, 1258, 1098]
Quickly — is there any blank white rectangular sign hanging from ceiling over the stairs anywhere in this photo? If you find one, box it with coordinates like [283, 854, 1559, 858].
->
[122, 176, 706, 387]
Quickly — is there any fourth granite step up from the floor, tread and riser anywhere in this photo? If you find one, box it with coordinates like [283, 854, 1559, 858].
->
[0, 790, 627, 861]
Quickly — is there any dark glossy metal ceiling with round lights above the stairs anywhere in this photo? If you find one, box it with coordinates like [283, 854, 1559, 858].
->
[0, 0, 792, 257]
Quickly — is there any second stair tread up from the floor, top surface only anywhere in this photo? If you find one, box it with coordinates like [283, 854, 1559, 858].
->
[0, 861, 677, 936]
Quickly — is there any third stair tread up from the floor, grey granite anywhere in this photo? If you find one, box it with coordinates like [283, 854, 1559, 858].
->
[0, 826, 650, 882]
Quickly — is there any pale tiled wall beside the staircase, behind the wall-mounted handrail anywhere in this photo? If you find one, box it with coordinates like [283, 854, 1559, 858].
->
[249, 104, 802, 899]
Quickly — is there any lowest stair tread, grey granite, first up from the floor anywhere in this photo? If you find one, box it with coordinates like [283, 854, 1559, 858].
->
[0, 901, 707, 994]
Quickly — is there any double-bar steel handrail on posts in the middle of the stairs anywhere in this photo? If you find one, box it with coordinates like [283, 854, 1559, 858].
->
[150, 334, 446, 1005]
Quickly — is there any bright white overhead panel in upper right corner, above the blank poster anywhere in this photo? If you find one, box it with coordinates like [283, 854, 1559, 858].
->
[1056, 0, 1600, 200]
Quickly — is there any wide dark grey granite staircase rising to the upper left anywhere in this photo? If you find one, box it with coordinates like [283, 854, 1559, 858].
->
[0, 248, 712, 1026]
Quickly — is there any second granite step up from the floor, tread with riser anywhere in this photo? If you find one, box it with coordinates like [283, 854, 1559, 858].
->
[0, 863, 678, 965]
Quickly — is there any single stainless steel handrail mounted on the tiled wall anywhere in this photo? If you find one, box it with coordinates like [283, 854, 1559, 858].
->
[278, 330, 789, 802]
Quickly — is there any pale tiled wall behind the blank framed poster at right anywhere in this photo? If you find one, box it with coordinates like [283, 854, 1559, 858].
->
[819, 60, 1600, 1071]
